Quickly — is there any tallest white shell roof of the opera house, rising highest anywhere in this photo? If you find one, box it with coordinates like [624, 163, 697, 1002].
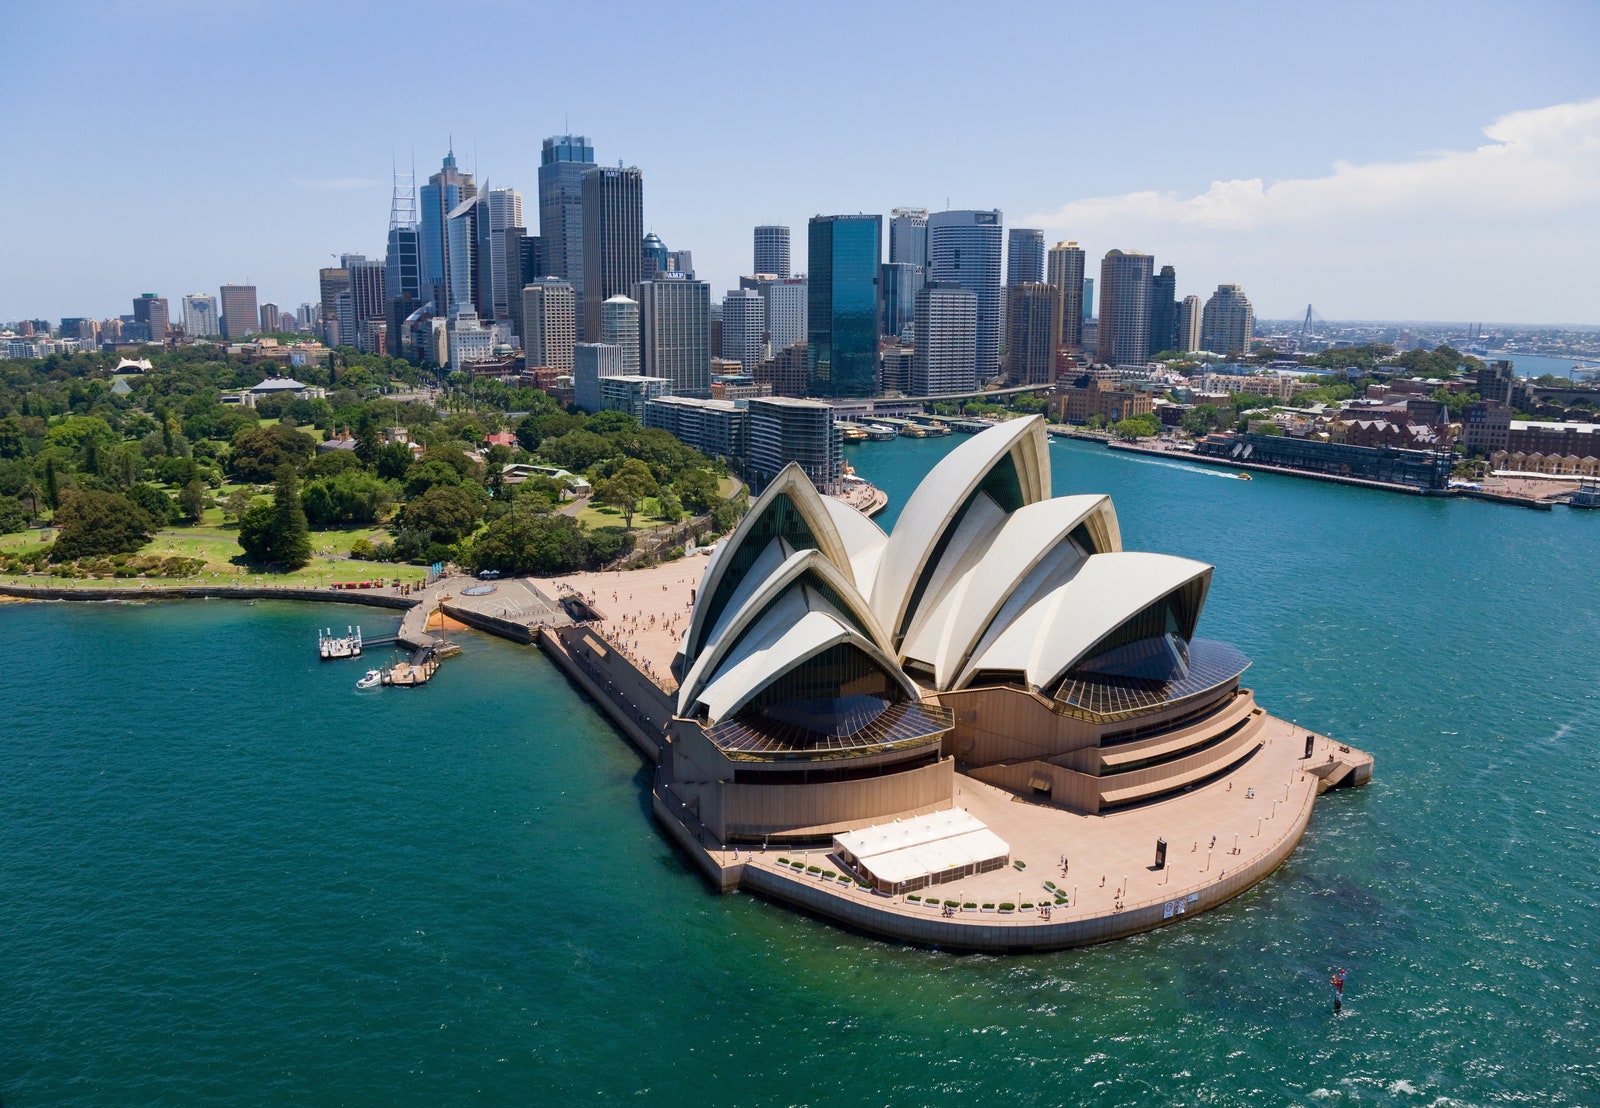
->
[872, 416, 1050, 634]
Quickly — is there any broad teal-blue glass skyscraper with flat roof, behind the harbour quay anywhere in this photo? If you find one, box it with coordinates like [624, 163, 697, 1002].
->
[806, 215, 883, 399]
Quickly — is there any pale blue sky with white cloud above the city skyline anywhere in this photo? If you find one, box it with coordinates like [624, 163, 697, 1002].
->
[0, 0, 1600, 323]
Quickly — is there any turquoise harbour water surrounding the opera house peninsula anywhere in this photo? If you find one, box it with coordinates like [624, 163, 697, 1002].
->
[0, 437, 1600, 1108]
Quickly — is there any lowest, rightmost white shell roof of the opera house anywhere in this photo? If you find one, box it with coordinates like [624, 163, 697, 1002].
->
[952, 552, 1211, 688]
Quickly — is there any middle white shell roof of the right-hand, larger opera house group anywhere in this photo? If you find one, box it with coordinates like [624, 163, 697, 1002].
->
[901, 495, 1120, 688]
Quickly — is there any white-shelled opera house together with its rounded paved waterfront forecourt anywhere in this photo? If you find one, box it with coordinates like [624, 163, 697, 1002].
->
[654, 416, 1373, 951]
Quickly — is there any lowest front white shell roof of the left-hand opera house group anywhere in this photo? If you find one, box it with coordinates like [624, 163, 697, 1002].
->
[680, 588, 920, 724]
